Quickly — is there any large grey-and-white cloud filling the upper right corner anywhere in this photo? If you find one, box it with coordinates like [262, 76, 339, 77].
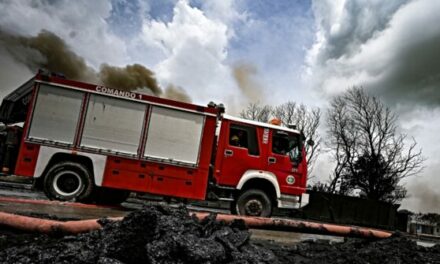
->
[307, 0, 440, 103]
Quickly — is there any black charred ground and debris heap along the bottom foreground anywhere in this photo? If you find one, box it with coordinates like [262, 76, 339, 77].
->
[0, 206, 440, 264]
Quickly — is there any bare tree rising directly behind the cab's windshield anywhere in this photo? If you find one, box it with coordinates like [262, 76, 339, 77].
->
[272, 101, 321, 174]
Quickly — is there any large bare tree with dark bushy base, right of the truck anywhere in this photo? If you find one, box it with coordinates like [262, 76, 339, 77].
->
[327, 87, 424, 203]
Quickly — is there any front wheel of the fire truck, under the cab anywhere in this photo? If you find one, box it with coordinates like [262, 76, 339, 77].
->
[232, 189, 272, 217]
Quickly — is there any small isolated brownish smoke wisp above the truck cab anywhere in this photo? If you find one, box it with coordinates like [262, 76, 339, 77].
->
[233, 63, 263, 102]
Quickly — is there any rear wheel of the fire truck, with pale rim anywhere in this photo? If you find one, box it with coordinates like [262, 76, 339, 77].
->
[43, 161, 94, 202]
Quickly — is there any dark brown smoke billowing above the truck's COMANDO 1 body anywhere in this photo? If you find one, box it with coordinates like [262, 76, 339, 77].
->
[0, 30, 191, 102]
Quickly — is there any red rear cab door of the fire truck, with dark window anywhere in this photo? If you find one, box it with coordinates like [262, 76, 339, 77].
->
[215, 120, 265, 187]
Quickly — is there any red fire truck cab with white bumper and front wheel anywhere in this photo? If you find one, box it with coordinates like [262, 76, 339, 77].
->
[214, 115, 307, 216]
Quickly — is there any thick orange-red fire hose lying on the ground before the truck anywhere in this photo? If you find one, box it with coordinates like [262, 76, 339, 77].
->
[0, 212, 392, 238]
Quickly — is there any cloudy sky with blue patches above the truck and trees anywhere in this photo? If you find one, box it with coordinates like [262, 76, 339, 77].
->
[0, 0, 440, 213]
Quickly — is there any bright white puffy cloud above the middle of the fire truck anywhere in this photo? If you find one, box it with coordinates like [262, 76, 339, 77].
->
[143, 1, 236, 104]
